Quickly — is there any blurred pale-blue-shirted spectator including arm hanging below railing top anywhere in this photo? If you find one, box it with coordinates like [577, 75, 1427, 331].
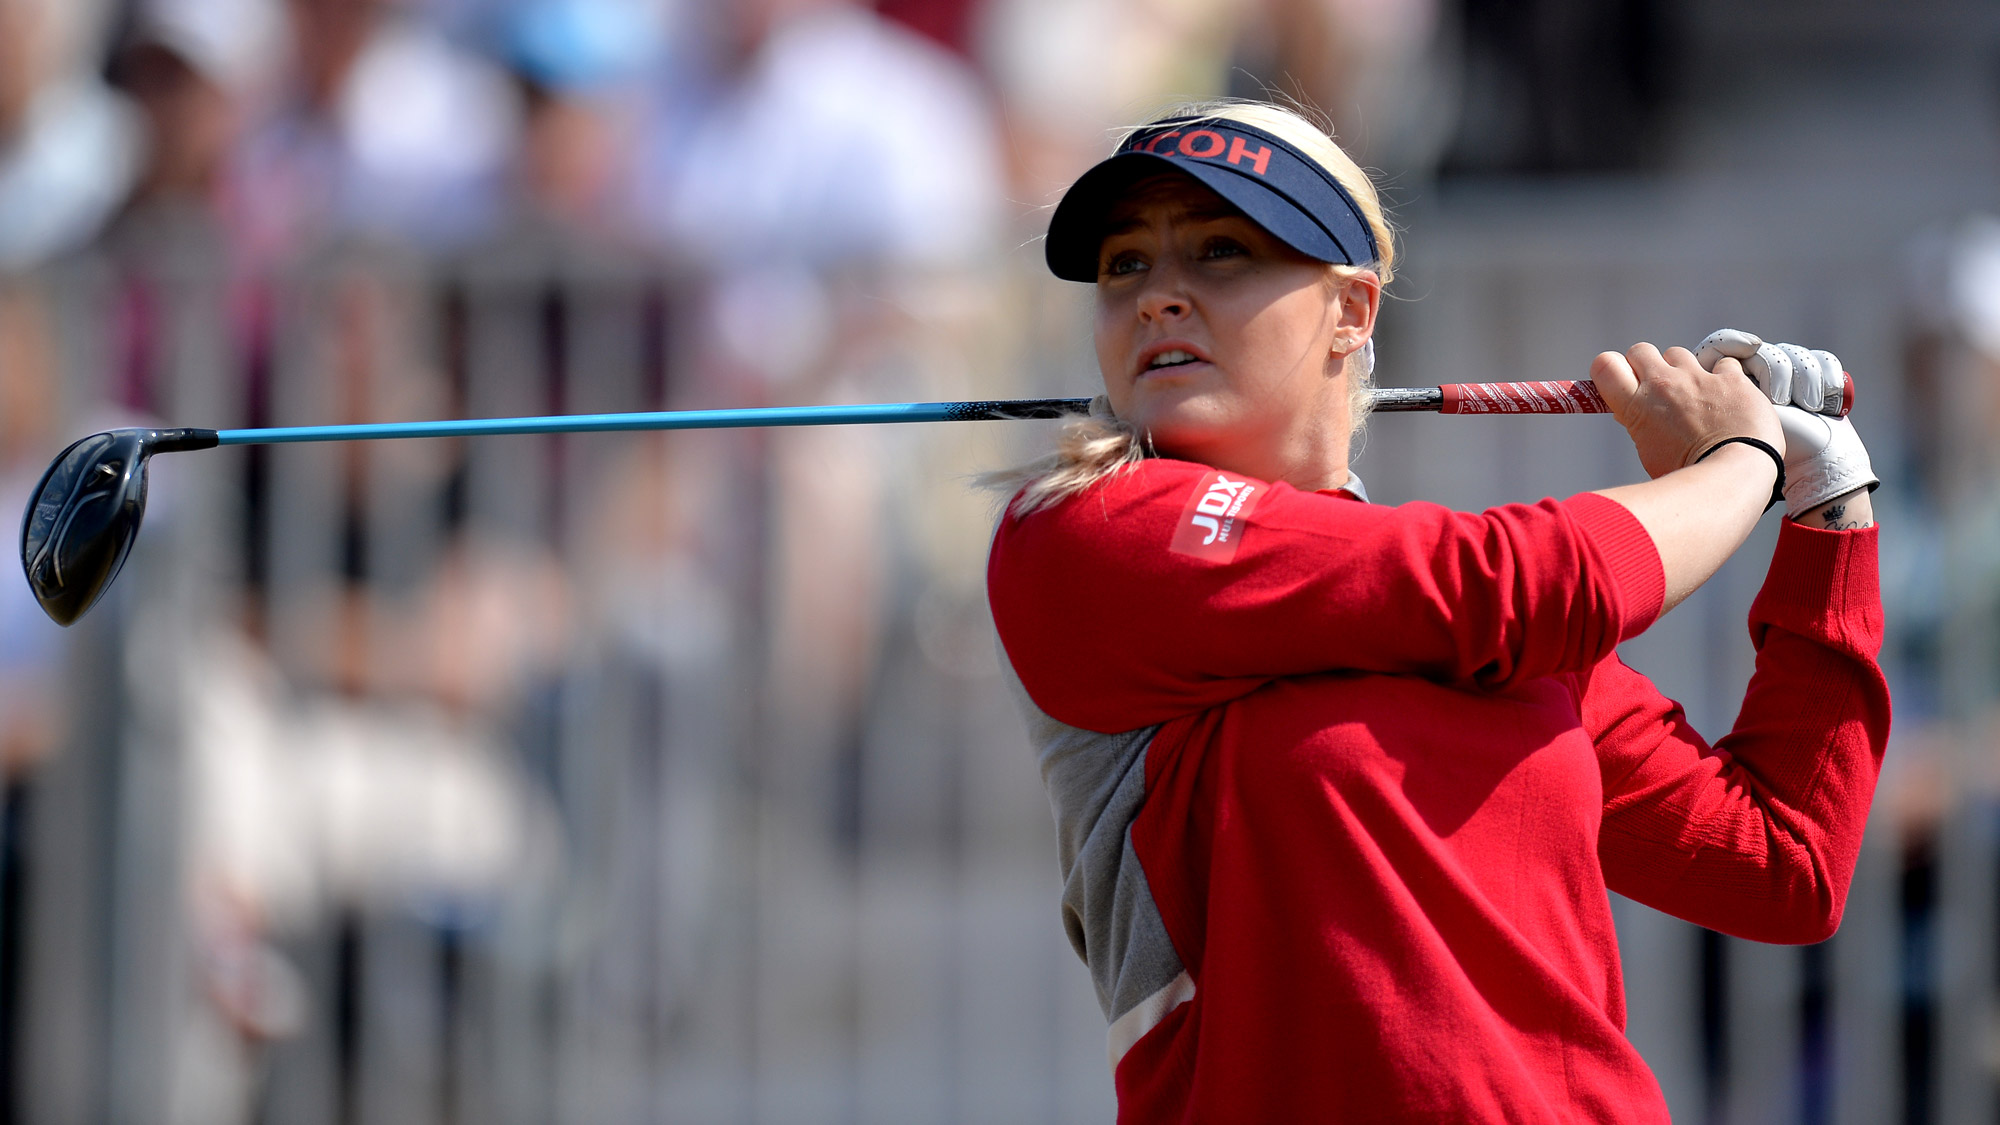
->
[638, 0, 1002, 400]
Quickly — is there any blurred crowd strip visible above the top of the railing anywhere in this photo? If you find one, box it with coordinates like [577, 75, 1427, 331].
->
[0, 0, 1480, 280]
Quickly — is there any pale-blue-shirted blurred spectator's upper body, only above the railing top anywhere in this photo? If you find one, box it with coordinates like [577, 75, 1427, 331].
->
[646, 0, 998, 268]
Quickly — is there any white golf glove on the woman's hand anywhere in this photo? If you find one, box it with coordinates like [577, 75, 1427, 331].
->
[1694, 328, 1880, 518]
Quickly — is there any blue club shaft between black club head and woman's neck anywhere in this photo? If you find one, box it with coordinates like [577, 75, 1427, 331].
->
[216, 398, 1090, 444]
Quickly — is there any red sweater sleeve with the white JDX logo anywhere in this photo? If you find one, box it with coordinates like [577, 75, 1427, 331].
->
[988, 460, 1664, 731]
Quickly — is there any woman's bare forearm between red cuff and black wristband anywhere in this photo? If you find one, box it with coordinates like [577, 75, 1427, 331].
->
[1598, 442, 1776, 613]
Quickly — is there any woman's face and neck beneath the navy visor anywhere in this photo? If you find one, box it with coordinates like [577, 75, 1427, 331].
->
[1096, 172, 1380, 488]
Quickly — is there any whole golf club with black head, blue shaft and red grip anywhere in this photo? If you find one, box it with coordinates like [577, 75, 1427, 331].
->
[20, 378, 1854, 625]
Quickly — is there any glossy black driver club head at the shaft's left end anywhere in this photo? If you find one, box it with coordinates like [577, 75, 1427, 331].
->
[20, 428, 216, 625]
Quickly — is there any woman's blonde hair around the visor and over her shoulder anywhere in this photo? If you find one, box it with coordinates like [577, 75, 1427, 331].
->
[980, 98, 1396, 514]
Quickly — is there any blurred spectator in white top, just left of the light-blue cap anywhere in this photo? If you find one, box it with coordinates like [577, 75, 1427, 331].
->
[236, 0, 520, 260]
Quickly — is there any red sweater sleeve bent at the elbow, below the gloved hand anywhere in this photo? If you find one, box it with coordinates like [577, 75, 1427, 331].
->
[1582, 520, 1890, 943]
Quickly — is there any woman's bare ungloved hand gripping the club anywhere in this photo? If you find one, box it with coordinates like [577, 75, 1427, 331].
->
[1590, 332, 1784, 478]
